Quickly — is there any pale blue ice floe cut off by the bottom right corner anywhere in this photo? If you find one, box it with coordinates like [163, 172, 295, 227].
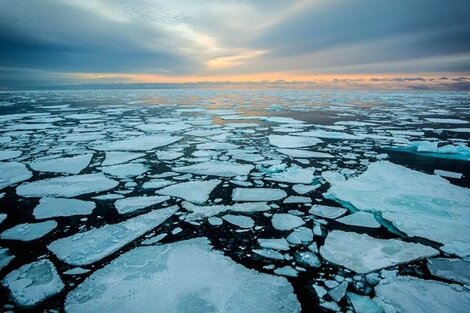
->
[374, 276, 470, 313]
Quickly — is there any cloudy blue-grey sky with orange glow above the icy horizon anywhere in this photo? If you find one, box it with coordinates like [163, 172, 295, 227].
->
[0, 0, 470, 89]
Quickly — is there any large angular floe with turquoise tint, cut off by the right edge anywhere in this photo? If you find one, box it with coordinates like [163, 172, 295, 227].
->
[327, 161, 470, 257]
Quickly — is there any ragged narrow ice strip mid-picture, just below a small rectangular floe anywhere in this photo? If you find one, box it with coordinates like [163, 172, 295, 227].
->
[182, 202, 271, 221]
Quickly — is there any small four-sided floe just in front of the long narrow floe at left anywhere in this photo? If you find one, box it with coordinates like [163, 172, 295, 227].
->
[33, 197, 96, 219]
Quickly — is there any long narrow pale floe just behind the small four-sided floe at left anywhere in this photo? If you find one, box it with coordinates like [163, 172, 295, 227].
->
[16, 174, 118, 198]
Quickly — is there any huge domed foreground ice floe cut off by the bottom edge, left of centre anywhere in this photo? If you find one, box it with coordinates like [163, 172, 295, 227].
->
[65, 238, 300, 313]
